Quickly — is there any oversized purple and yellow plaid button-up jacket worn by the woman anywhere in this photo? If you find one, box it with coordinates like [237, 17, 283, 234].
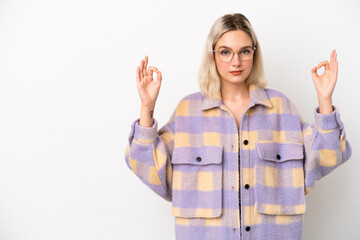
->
[125, 85, 351, 240]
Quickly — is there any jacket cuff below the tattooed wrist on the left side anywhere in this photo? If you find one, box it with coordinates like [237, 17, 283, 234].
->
[129, 118, 158, 144]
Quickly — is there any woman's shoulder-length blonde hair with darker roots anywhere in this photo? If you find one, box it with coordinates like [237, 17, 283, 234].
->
[199, 13, 266, 98]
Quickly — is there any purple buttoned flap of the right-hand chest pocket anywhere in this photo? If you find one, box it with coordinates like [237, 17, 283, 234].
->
[256, 142, 304, 162]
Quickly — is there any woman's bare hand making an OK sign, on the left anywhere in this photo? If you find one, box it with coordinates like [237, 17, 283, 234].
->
[136, 56, 162, 107]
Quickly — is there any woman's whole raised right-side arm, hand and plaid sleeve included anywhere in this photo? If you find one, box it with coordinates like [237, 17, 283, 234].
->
[302, 50, 351, 194]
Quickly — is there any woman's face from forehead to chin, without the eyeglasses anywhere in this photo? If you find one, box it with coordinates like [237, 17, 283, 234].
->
[215, 30, 253, 84]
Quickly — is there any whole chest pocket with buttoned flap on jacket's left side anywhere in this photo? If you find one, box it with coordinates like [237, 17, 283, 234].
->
[171, 146, 223, 218]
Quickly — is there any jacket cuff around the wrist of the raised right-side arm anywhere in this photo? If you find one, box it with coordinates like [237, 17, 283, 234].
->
[314, 105, 343, 130]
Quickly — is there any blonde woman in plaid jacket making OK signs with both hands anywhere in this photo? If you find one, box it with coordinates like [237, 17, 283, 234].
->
[125, 14, 351, 240]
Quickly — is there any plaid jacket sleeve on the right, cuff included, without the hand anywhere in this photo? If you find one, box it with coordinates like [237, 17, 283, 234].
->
[301, 106, 351, 194]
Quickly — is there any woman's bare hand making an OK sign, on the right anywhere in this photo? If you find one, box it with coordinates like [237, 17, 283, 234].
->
[311, 49, 338, 100]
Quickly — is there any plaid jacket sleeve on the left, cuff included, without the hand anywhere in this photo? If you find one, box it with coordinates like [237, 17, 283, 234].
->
[125, 111, 175, 201]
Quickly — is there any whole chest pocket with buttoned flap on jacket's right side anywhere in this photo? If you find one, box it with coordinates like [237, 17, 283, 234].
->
[255, 142, 305, 215]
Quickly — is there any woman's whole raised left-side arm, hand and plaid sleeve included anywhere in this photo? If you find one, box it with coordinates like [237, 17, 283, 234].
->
[125, 56, 174, 201]
